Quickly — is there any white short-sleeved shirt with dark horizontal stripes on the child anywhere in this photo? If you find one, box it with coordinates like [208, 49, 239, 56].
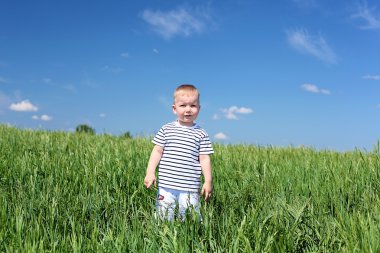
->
[152, 121, 214, 192]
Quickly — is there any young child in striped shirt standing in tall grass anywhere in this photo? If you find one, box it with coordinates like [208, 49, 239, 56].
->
[144, 84, 214, 220]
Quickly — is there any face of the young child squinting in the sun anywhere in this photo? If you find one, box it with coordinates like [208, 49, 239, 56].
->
[173, 93, 200, 126]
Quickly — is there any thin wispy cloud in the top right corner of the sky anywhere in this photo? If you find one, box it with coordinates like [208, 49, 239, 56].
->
[351, 1, 380, 30]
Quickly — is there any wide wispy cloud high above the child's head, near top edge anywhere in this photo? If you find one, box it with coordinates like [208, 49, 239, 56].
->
[141, 8, 207, 39]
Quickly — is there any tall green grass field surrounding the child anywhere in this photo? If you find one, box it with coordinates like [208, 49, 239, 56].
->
[0, 125, 380, 252]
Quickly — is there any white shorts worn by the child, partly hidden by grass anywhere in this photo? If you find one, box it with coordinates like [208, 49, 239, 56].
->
[157, 187, 202, 220]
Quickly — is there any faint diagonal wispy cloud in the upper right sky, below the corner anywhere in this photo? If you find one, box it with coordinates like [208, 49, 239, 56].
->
[287, 29, 336, 63]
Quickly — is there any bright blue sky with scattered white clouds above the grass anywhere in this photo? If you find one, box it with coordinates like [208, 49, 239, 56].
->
[0, 0, 380, 151]
